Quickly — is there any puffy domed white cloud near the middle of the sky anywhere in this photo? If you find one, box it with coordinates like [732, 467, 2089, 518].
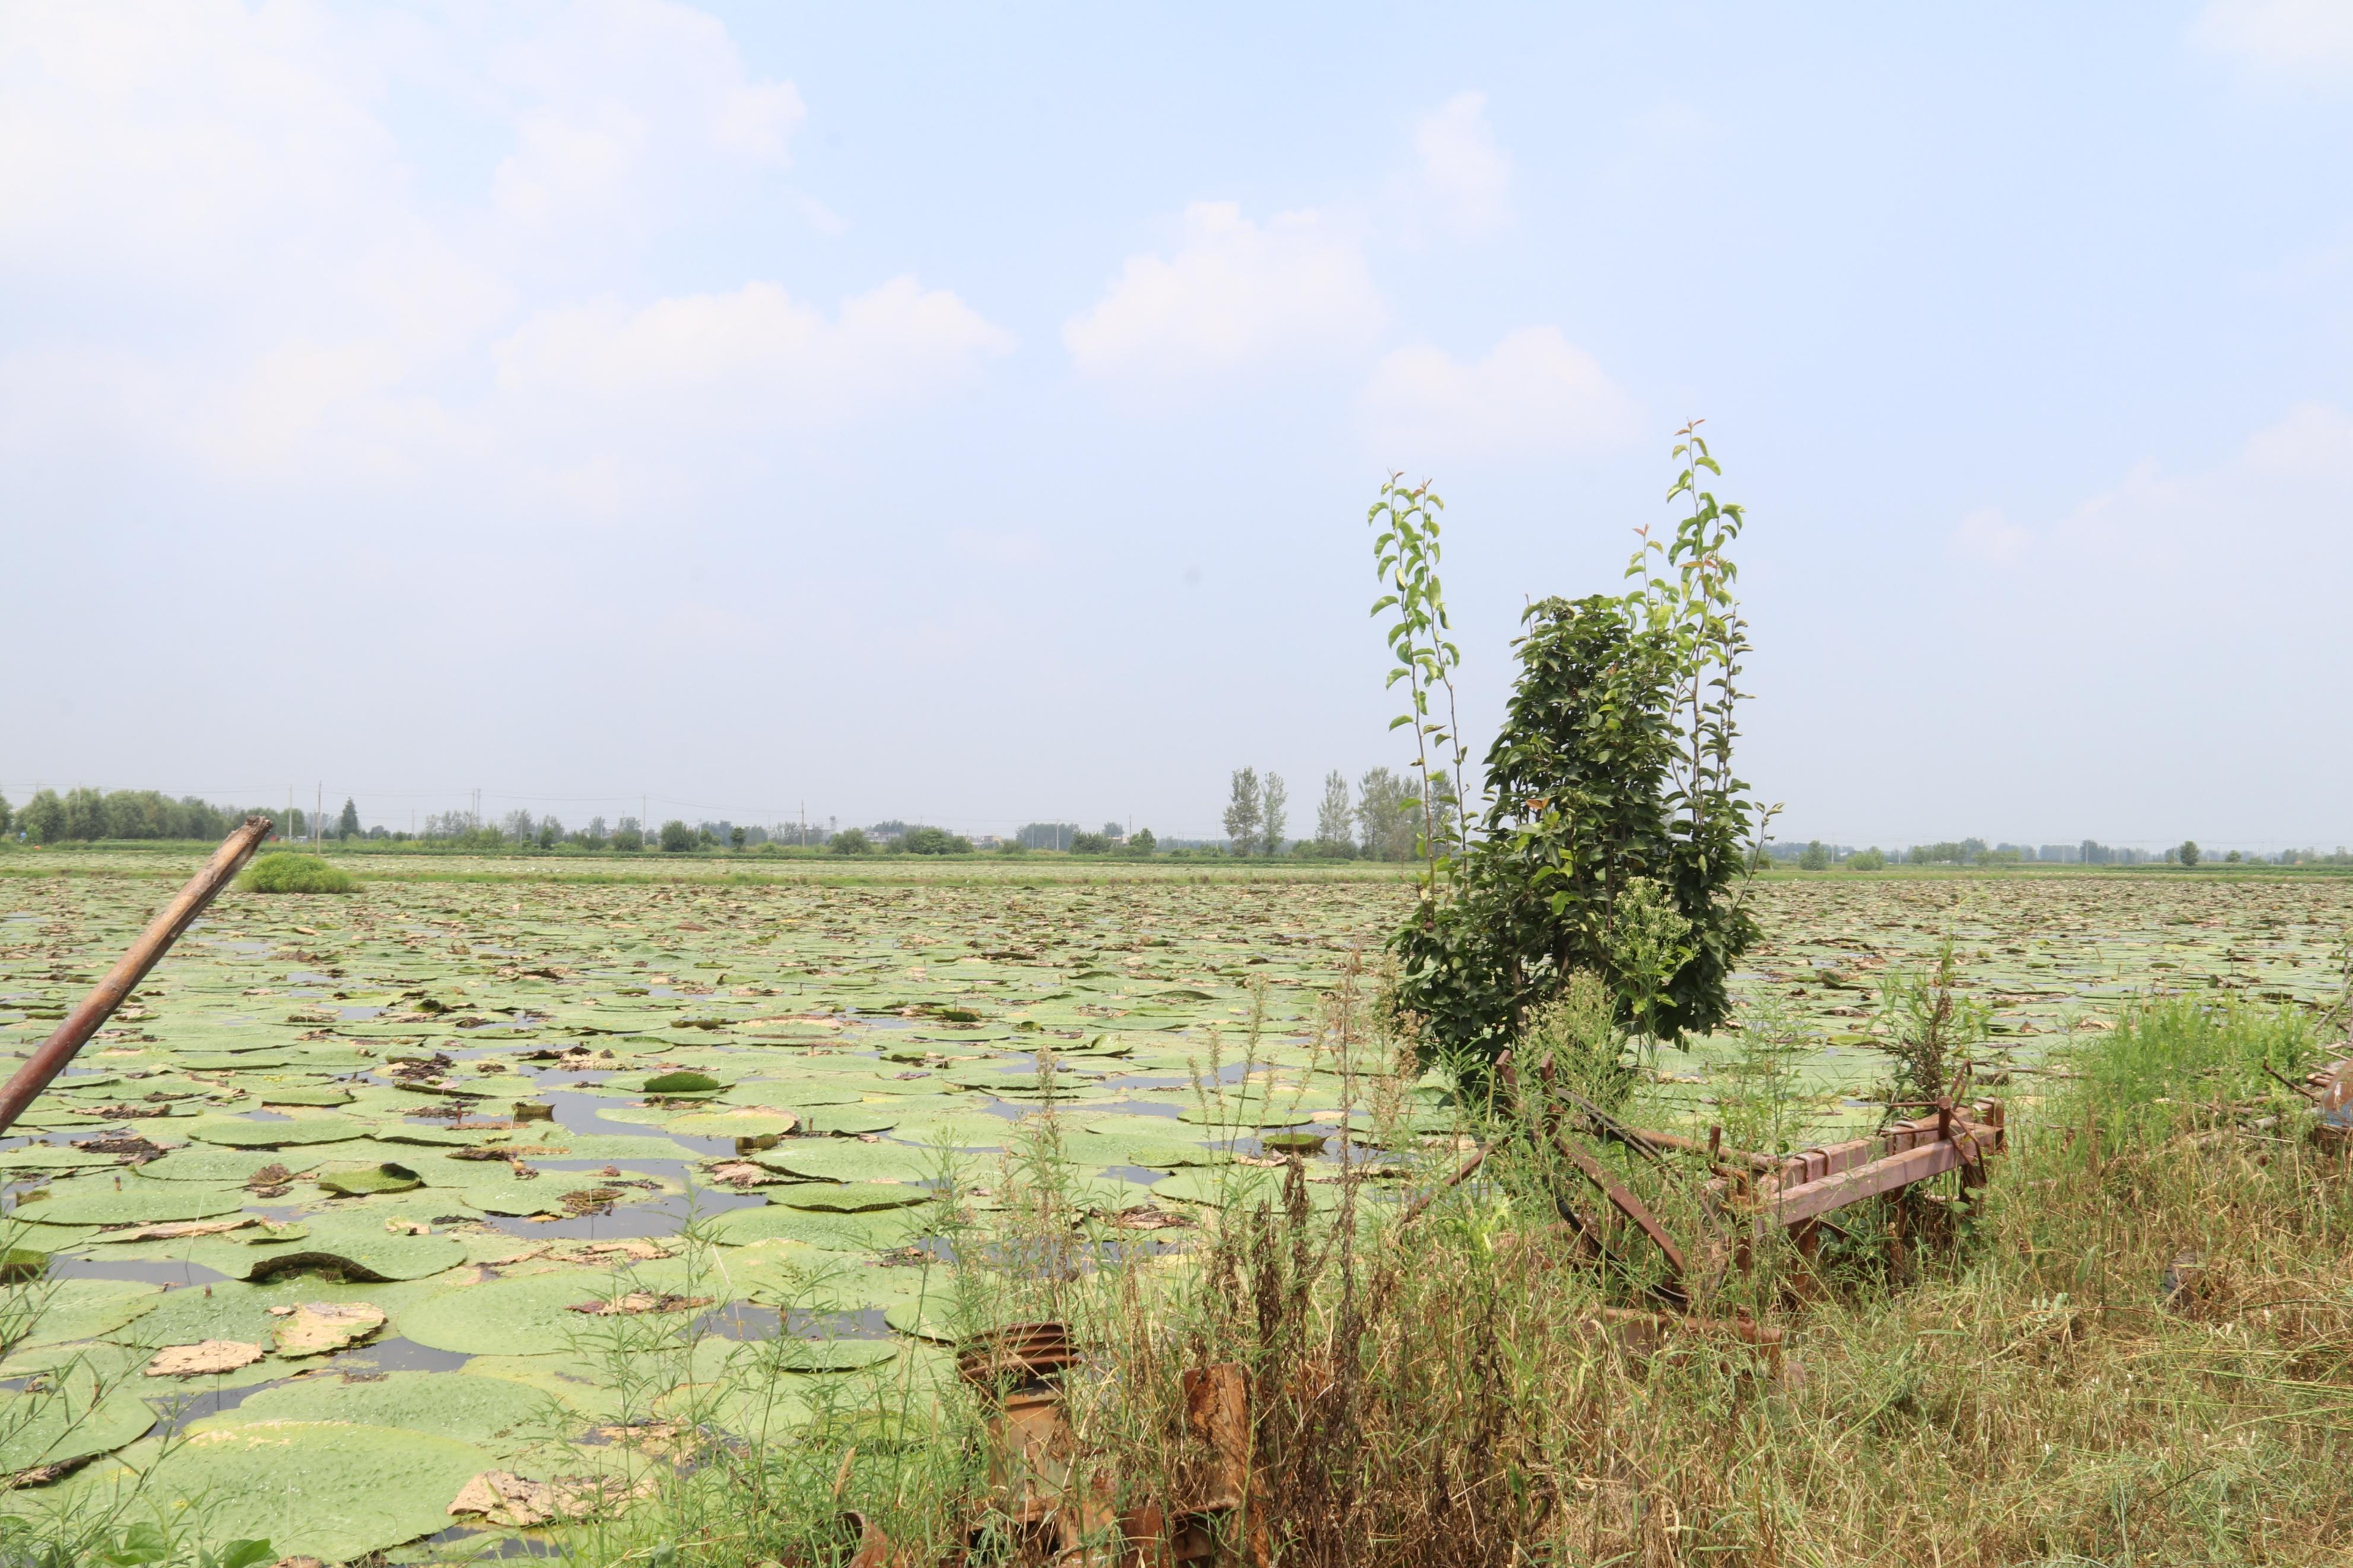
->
[1061, 202, 1388, 381]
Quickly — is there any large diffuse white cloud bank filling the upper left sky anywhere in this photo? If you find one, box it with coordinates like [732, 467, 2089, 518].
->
[0, 0, 1009, 501]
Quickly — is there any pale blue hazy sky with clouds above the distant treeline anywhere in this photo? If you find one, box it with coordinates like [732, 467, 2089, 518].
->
[0, 0, 2353, 844]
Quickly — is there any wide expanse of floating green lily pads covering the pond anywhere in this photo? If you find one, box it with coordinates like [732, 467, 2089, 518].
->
[0, 855, 2353, 1561]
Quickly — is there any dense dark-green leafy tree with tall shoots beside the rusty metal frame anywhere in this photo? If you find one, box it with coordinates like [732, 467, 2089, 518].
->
[1383, 425, 1770, 1074]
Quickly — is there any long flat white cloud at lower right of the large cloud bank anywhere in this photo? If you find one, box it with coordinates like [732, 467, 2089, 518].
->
[492, 278, 1014, 423]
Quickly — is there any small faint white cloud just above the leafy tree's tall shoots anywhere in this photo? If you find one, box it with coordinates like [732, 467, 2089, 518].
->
[1360, 327, 1640, 463]
